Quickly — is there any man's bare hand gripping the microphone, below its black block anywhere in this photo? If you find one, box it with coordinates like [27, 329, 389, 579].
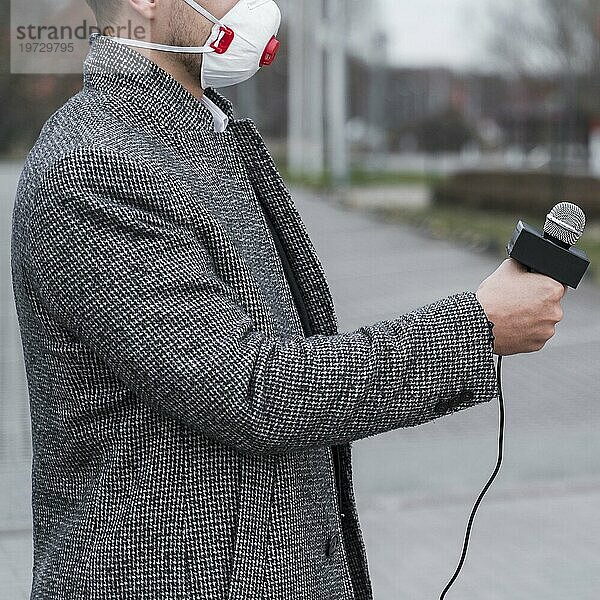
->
[476, 259, 567, 356]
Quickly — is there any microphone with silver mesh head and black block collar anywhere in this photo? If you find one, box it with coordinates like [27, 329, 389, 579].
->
[507, 202, 590, 288]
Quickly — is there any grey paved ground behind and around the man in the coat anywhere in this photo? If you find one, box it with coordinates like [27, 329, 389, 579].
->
[0, 165, 600, 600]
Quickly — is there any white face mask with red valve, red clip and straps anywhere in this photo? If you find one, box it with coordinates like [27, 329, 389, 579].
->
[111, 0, 281, 89]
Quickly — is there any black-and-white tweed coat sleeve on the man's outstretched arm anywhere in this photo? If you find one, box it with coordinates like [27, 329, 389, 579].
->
[27, 150, 497, 454]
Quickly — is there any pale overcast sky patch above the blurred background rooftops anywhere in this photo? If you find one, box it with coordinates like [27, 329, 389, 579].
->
[372, 0, 500, 68]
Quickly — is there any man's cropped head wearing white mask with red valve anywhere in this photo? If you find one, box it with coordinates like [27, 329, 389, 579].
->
[88, 0, 281, 98]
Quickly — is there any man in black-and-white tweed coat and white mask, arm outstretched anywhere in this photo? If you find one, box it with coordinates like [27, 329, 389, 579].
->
[13, 0, 564, 600]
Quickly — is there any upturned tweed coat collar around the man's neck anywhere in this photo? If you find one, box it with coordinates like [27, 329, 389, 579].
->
[83, 34, 233, 132]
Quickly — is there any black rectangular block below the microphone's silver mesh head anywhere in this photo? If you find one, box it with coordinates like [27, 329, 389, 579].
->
[507, 221, 590, 289]
